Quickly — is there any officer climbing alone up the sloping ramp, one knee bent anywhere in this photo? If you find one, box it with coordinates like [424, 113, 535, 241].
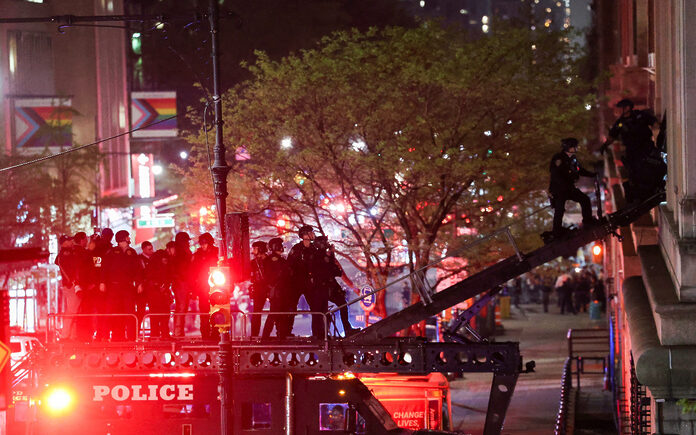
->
[549, 137, 597, 237]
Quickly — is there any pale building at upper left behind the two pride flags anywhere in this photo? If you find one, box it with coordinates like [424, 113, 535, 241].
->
[0, 0, 133, 235]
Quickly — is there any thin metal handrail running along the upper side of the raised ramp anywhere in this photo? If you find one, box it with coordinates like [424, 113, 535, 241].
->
[328, 206, 550, 315]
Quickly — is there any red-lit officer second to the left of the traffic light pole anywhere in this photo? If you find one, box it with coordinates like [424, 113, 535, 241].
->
[171, 231, 194, 337]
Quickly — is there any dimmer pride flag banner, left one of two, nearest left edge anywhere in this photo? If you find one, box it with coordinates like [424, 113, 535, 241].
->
[12, 97, 75, 151]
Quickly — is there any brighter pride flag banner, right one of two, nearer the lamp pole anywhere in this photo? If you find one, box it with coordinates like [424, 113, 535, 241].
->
[131, 92, 178, 138]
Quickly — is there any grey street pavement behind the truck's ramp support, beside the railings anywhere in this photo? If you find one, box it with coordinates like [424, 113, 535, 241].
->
[450, 304, 612, 435]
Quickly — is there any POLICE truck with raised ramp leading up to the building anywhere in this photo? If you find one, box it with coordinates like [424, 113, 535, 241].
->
[23, 193, 664, 435]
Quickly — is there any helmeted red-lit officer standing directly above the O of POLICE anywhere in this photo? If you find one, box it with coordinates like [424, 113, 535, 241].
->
[99, 230, 143, 341]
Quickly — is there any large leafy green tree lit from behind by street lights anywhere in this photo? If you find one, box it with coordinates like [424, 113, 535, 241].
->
[184, 22, 593, 314]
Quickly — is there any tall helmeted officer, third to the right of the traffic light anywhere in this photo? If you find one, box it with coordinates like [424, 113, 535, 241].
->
[288, 225, 323, 338]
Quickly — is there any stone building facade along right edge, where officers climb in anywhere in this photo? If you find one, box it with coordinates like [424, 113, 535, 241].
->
[595, 0, 696, 434]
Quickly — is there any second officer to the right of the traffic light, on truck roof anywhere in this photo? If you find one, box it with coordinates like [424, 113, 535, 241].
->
[261, 237, 297, 338]
